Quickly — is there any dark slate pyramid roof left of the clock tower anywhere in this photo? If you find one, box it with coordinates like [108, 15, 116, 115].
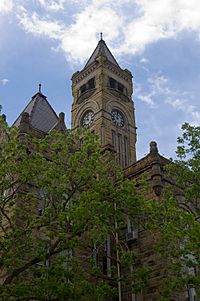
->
[13, 92, 58, 133]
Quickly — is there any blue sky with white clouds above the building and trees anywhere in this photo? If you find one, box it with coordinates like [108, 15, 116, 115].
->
[0, 0, 200, 159]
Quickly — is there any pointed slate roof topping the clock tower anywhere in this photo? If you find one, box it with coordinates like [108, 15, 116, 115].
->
[85, 39, 119, 68]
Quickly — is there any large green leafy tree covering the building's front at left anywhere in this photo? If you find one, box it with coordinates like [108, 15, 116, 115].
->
[0, 118, 149, 301]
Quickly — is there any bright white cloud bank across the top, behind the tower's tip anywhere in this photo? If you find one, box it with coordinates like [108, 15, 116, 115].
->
[3, 0, 200, 63]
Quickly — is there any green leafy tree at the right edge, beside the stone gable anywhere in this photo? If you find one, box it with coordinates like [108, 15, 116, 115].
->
[144, 123, 200, 300]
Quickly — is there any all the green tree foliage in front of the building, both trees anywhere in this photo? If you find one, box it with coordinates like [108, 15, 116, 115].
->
[0, 117, 200, 301]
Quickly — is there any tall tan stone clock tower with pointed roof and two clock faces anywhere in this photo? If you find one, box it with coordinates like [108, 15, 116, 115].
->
[72, 39, 136, 168]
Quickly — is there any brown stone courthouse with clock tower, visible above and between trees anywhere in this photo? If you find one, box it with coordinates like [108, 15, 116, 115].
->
[11, 39, 195, 301]
